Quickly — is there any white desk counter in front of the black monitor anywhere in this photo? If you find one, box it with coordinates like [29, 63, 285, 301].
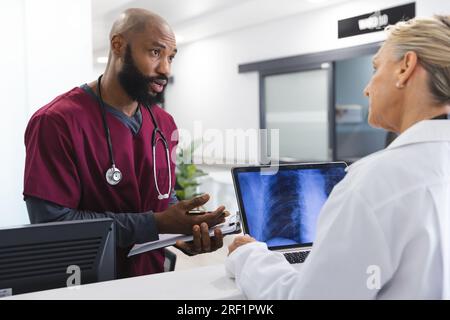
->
[4, 265, 245, 300]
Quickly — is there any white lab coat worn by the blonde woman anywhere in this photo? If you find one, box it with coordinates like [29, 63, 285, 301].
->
[226, 120, 450, 299]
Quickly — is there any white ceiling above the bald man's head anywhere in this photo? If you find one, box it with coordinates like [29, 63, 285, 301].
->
[92, 0, 348, 62]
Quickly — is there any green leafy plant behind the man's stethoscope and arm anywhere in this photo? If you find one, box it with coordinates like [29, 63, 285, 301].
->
[175, 141, 208, 200]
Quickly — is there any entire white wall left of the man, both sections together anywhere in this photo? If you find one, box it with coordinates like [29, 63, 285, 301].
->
[0, 0, 92, 227]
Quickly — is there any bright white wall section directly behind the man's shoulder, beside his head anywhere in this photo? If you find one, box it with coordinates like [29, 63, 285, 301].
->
[24, 0, 93, 115]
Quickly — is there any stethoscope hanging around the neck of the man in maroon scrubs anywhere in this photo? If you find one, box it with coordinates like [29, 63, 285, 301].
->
[97, 76, 172, 200]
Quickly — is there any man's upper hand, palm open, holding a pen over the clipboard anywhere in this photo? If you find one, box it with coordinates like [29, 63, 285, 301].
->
[154, 194, 226, 235]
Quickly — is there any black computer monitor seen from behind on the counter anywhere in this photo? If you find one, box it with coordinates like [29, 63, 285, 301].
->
[0, 219, 116, 296]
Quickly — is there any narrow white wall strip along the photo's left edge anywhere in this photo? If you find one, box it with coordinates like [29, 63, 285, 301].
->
[0, 0, 27, 226]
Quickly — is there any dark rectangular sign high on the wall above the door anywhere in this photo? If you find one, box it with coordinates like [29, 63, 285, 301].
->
[338, 2, 416, 39]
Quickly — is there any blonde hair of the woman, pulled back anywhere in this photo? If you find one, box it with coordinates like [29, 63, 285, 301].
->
[386, 15, 450, 105]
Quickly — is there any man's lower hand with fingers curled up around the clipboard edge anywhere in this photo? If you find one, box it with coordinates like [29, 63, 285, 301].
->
[175, 223, 223, 256]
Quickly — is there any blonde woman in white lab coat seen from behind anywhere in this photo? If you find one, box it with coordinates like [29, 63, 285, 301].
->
[226, 16, 450, 299]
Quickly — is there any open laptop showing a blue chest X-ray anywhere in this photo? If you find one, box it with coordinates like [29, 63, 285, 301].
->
[232, 162, 347, 264]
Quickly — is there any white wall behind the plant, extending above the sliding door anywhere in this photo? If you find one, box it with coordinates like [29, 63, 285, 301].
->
[166, 0, 450, 161]
